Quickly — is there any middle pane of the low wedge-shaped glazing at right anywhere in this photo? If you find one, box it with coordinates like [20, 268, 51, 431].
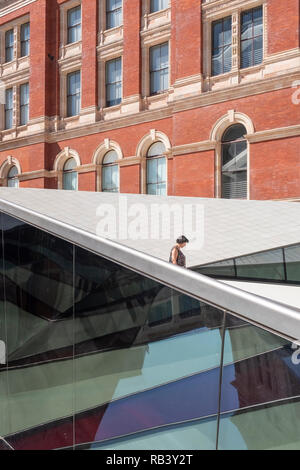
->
[236, 249, 285, 280]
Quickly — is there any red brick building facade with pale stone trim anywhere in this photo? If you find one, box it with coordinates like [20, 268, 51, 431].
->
[0, 0, 300, 200]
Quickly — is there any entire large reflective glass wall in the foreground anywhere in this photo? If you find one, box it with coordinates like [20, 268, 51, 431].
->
[0, 214, 300, 450]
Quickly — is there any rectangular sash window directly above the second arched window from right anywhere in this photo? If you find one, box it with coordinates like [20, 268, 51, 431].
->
[150, 42, 169, 95]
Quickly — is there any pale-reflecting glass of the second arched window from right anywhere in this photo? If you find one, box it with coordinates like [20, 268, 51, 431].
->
[147, 142, 167, 196]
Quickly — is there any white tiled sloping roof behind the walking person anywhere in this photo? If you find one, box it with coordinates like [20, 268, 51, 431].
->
[0, 188, 300, 266]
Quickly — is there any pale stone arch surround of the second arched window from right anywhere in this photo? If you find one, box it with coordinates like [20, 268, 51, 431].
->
[136, 129, 172, 195]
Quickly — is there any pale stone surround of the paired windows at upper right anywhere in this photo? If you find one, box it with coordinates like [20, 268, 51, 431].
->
[202, 0, 268, 85]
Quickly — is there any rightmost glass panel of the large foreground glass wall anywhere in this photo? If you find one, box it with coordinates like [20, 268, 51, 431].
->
[219, 315, 300, 450]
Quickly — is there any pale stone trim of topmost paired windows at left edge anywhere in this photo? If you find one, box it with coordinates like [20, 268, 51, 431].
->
[0, 15, 31, 67]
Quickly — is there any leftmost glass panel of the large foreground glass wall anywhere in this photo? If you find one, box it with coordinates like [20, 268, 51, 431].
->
[0, 215, 74, 450]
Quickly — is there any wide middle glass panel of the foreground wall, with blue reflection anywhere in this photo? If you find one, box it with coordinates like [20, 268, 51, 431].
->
[75, 248, 223, 449]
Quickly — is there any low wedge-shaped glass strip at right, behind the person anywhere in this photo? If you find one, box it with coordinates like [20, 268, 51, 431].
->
[193, 244, 300, 284]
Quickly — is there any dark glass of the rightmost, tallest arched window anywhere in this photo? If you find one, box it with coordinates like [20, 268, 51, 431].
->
[222, 124, 247, 199]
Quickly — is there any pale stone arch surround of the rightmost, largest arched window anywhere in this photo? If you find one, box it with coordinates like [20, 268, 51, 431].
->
[210, 109, 255, 200]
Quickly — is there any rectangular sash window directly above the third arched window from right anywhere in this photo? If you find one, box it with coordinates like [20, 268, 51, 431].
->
[105, 57, 122, 107]
